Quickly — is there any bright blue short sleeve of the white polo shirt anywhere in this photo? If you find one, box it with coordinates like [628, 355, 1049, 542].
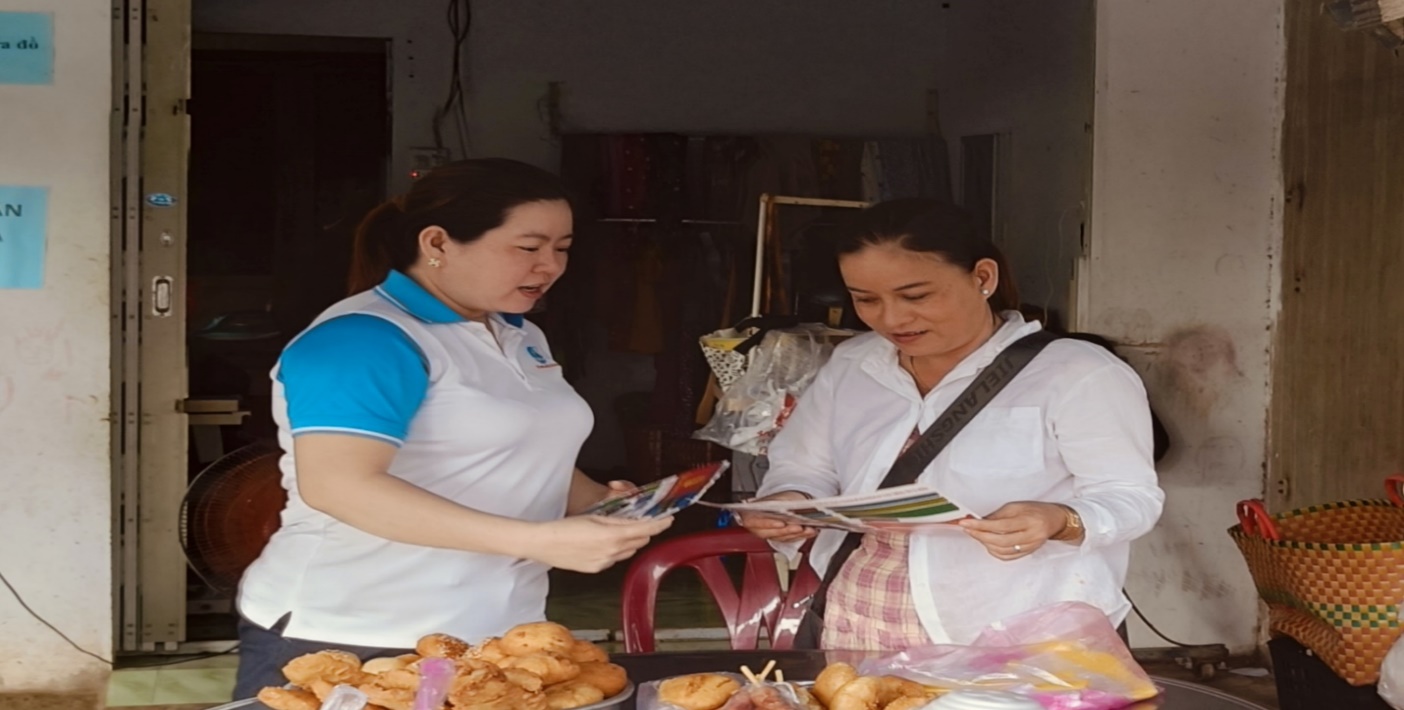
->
[278, 313, 430, 446]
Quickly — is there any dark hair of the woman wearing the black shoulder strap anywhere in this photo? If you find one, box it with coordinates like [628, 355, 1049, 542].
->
[834, 198, 1019, 312]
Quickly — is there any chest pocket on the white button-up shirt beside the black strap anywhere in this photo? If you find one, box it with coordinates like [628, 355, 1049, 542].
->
[951, 407, 1043, 477]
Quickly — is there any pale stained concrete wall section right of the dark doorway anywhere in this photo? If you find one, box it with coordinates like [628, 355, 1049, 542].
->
[1081, 0, 1283, 650]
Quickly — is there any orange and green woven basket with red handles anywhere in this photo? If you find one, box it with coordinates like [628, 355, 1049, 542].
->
[1229, 476, 1404, 685]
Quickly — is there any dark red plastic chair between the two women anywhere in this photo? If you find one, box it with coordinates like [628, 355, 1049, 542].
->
[621, 528, 819, 654]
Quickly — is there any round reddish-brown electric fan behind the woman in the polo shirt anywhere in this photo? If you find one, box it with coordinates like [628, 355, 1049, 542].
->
[180, 442, 288, 594]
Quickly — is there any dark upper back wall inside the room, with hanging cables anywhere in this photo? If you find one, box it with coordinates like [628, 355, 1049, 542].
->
[194, 0, 942, 189]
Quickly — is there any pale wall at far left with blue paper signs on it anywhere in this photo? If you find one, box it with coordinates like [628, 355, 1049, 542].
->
[0, 0, 112, 709]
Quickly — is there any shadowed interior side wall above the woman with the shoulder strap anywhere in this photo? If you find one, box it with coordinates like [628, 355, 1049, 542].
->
[934, 0, 1095, 321]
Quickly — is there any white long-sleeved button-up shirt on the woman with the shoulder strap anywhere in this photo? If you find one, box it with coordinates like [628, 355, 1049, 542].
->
[758, 312, 1165, 644]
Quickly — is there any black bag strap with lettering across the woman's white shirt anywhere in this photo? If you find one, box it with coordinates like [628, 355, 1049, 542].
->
[795, 330, 1057, 648]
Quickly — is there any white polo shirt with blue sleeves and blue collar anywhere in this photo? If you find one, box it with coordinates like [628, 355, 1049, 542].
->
[239, 272, 594, 648]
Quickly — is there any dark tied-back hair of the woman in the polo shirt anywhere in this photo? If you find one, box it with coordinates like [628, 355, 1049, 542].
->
[348, 157, 570, 293]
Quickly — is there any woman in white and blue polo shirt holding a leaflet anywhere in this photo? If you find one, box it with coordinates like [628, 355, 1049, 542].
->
[234, 160, 671, 697]
